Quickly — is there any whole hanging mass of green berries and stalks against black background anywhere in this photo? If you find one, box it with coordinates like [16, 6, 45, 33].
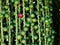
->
[0, 0, 55, 45]
